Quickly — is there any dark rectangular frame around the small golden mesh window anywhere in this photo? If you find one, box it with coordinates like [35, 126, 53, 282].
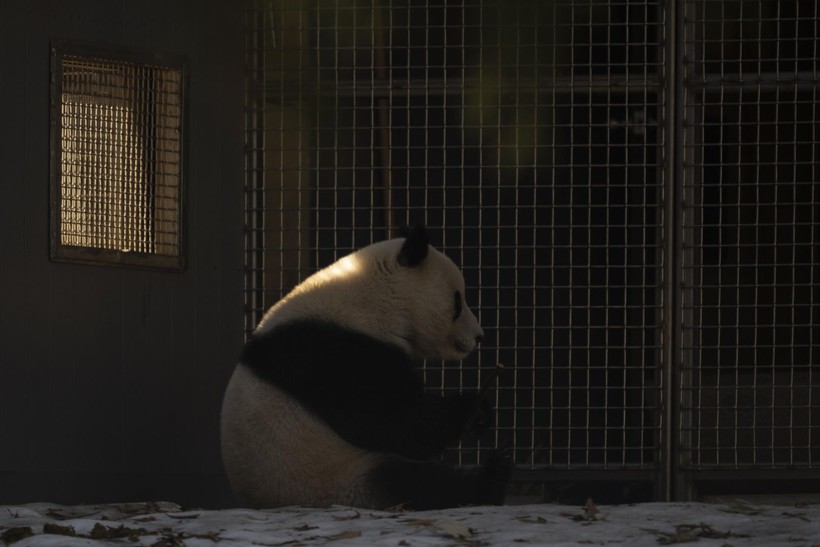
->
[49, 40, 188, 271]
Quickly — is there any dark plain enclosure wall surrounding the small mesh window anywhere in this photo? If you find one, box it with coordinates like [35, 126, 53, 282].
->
[0, 0, 244, 506]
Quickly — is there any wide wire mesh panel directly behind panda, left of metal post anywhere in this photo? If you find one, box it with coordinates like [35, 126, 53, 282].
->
[246, 0, 664, 469]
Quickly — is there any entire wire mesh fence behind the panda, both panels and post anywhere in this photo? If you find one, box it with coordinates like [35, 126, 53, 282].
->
[246, 0, 820, 498]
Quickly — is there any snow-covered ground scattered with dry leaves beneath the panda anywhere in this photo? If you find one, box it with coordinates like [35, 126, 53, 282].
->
[0, 500, 820, 547]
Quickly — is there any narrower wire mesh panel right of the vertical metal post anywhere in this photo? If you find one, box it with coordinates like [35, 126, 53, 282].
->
[681, 0, 820, 470]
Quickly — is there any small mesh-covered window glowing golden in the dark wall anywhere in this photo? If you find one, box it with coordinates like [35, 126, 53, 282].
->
[51, 45, 184, 268]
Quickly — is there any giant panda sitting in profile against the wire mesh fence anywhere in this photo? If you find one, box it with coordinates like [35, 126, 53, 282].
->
[221, 227, 511, 509]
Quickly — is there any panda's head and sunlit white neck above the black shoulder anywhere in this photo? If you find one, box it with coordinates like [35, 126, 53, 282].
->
[257, 227, 484, 360]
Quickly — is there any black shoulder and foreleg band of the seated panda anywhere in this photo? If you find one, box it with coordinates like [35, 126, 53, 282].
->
[240, 319, 477, 458]
